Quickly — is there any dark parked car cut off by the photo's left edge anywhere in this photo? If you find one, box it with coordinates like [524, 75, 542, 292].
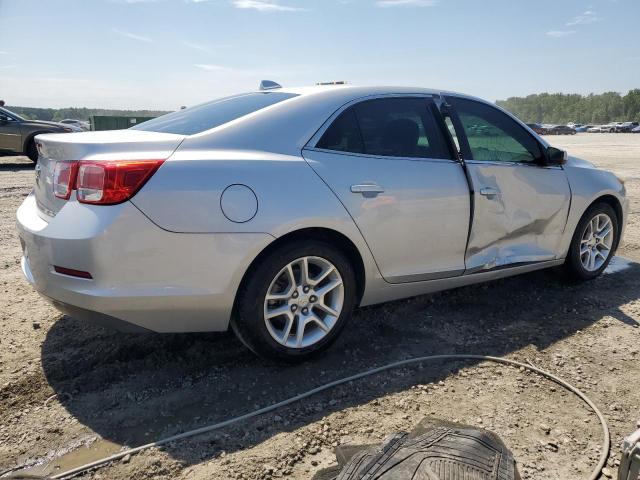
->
[0, 107, 82, 162]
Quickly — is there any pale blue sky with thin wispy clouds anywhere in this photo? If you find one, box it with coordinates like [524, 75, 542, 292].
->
[0, 0, 640, 110]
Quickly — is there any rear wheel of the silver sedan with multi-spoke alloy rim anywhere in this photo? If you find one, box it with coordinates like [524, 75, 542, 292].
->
[231, 241, 356, 361]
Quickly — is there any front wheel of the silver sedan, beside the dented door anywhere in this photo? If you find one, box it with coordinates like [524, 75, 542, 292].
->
[563, 203, 618, 281]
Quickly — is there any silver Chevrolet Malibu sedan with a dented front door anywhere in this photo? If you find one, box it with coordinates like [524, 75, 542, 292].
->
[17, 82, 628, 360]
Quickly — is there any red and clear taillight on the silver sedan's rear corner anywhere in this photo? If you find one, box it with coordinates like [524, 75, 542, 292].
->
[54, 160, 164, 205]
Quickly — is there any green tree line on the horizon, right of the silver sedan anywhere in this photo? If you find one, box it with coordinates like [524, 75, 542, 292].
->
[496, 88, 640, 124]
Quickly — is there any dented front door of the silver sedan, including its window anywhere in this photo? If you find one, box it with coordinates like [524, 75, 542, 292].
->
[447, 96, 571, 273]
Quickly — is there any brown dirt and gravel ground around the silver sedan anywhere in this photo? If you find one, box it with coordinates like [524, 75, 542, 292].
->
[0, 134, 640, 480]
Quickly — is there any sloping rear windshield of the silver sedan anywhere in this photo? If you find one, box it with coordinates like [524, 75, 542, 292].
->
[131, 92, 297, 135]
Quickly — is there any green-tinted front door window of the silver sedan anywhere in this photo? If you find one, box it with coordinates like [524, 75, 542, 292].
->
[448, 97, 542, 162]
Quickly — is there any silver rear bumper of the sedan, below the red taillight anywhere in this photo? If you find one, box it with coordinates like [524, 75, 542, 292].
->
[17, 195, 273, 332]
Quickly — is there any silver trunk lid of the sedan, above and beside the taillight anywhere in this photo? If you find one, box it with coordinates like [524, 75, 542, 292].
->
[34, 130, 185, 220]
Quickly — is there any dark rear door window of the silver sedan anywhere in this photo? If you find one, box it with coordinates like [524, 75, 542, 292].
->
[316, 97, 450, 158]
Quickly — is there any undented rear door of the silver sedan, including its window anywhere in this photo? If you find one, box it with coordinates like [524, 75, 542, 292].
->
[303, 96, 470, 283]
